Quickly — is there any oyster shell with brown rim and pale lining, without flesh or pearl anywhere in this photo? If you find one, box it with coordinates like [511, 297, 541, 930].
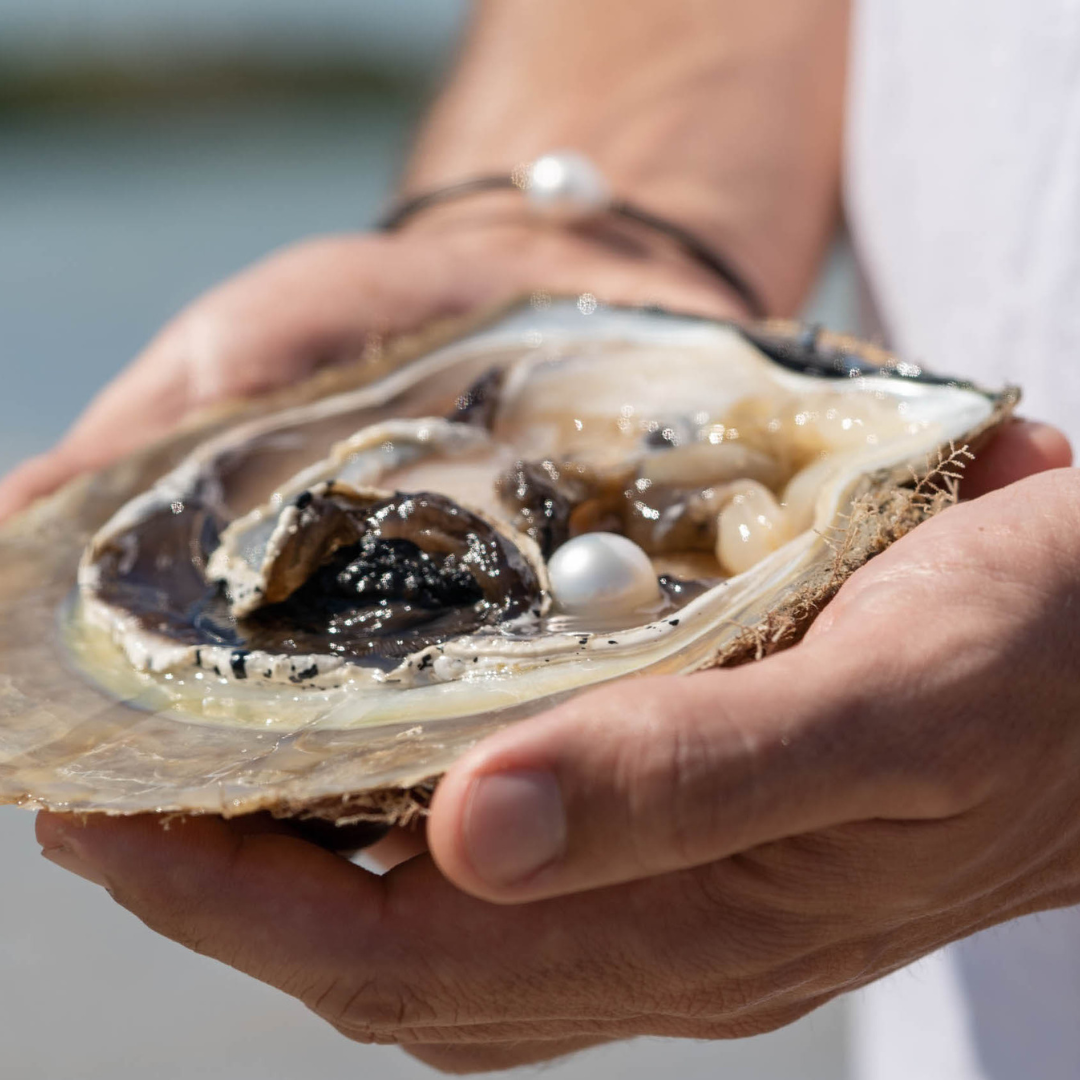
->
[0, 300, 1016, 822]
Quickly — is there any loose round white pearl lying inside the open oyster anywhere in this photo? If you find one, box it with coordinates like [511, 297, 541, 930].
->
[548, 532, 660, 616]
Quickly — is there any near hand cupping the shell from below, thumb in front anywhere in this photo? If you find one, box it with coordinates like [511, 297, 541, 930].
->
[31, 428, 1080, 1071]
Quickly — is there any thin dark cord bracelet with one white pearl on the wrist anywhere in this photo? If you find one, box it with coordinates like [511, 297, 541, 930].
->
[376, 150, 767, 319]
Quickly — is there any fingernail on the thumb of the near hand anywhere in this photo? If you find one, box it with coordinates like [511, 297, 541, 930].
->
[464, 771, 566, 886]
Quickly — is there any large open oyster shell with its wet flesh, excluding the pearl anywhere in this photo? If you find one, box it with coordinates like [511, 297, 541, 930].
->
[0, 300, 1016, 822]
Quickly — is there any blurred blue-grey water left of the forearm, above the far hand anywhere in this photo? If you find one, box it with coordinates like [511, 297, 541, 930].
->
[0, 98, 415, 467]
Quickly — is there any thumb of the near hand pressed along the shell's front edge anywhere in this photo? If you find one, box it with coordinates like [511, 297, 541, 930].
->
[428, 642, 919, 903]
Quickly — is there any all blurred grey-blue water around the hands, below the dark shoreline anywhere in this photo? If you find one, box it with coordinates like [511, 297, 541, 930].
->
[0, 95, 850, 1080]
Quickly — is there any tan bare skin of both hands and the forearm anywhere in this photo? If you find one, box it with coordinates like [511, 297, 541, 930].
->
[0, 0, 1080, 1072]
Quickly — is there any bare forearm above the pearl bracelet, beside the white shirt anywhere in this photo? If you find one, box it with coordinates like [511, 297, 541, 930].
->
[406, 0, 847, 312]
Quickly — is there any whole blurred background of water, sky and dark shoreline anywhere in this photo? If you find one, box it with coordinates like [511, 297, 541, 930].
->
[0, 0, 854, 1080]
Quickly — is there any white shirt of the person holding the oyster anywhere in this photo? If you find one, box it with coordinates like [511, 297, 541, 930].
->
[847, 0, 1080, 1080]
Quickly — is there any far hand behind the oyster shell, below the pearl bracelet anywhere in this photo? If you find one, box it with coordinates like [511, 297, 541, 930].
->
[0, 217, 739, 521]
